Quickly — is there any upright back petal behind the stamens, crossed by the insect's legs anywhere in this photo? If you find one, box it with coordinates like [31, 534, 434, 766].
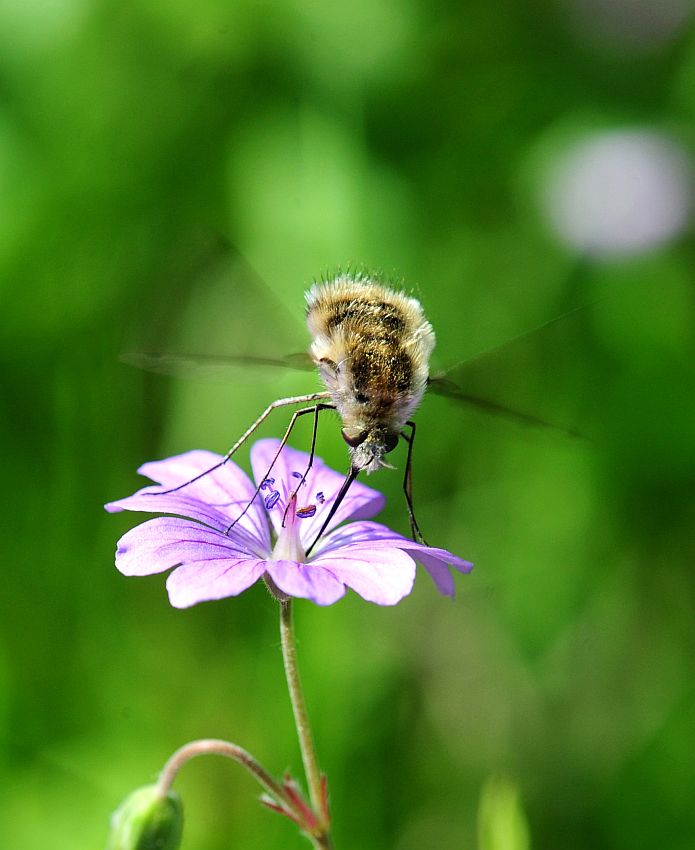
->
[251, 439, 386, 548]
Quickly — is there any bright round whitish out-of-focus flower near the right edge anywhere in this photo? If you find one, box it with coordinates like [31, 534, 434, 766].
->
[542, 130, 693, 256]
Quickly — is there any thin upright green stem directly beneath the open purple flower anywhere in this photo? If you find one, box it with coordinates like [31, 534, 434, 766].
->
[280, 599, 330, 836]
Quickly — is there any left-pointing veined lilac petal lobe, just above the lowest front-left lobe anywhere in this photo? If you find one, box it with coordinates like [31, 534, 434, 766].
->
[116, 517, 266, 576]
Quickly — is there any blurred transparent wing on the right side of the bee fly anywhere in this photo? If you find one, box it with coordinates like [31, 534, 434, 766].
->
[428, 274, 678, 438]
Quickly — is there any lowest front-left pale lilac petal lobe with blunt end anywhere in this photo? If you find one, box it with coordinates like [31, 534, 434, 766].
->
[167, 558, 265, 608]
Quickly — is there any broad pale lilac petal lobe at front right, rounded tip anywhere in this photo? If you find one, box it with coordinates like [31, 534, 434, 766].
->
[313, 545, 415, 605]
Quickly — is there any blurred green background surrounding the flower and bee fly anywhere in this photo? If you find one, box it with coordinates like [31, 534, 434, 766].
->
[0, 0, 695, 850]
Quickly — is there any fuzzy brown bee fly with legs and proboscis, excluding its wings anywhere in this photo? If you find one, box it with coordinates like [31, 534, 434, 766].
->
[157, 274, 435, 554]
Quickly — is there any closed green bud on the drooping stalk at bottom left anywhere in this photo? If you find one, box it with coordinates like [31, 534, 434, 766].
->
[106, 785, 183, 850]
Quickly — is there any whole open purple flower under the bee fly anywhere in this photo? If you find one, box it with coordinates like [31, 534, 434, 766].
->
[106, 439, 472, 608]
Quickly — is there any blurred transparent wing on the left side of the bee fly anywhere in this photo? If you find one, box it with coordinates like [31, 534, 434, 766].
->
[120, 238, 313, 382]
